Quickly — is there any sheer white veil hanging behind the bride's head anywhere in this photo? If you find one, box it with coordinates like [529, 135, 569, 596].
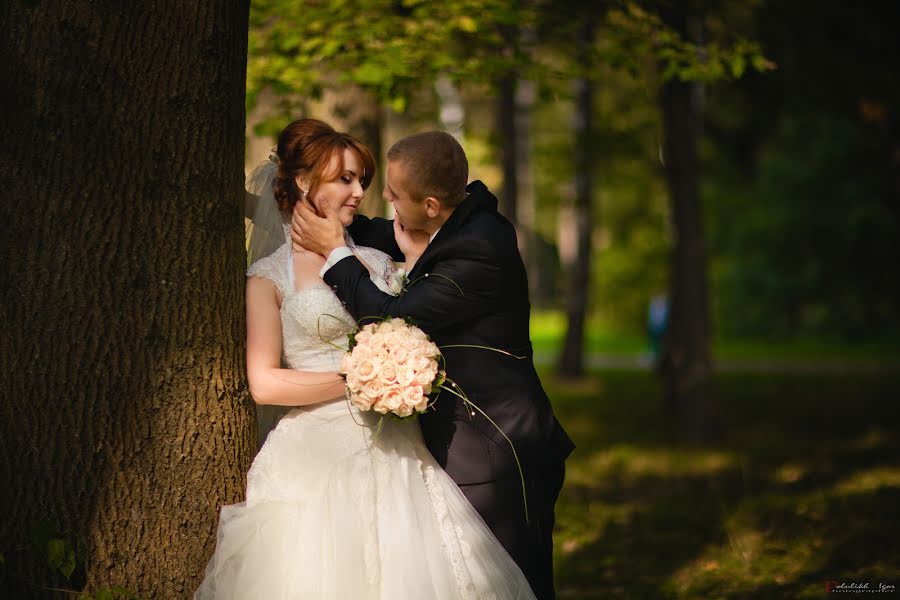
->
[244, 155, 288, 267]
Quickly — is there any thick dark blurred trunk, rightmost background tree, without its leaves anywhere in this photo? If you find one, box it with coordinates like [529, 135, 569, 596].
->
[659, 12, 713, 440]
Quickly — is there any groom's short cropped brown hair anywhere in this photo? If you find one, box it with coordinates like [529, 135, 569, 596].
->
[388, 131, 469, 207]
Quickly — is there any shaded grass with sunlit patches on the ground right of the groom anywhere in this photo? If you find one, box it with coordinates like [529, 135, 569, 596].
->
[543, 372, 900, 599]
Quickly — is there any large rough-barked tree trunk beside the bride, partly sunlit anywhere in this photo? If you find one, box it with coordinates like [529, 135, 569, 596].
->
[0, 0, 255, 598]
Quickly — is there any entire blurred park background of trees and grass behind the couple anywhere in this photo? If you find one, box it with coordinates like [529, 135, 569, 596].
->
[247, 0, 900, 598]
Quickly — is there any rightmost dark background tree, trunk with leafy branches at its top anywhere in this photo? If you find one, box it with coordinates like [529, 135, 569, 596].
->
[657, 1, 773, 441]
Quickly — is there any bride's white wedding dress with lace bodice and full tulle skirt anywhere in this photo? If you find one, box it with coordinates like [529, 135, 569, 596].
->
[194, 244, 534, 600]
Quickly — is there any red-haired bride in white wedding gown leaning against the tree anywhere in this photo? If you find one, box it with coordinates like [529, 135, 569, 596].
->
[194, 119, 534, 600]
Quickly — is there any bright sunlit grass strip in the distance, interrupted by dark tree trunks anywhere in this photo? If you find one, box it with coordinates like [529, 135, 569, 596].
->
[531, 311, 900, 361]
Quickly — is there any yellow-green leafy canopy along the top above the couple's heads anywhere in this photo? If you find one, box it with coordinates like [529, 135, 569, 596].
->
[247, 0, 772, 124]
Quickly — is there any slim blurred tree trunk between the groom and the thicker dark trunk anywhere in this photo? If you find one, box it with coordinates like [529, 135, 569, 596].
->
[558, 15, 596, 377]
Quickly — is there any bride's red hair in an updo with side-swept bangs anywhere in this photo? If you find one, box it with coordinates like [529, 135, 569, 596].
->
[272, 119, 375, 214]
